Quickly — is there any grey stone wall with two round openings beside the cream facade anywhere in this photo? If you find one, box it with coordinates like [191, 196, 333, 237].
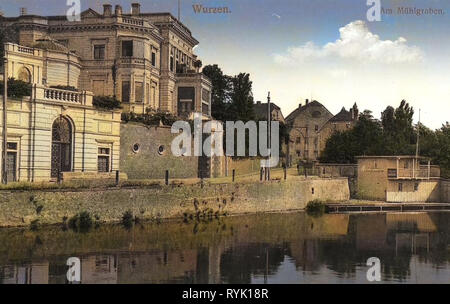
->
[120, 122, 198, 179]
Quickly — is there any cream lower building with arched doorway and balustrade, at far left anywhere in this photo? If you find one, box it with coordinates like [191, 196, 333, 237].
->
[0, 43, 121, 182]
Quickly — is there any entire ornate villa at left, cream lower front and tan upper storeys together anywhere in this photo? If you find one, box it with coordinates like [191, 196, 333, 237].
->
[0, 3, 211, 182]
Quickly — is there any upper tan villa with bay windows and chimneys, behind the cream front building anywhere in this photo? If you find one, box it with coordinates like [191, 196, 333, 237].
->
[0, 3, 211, 117]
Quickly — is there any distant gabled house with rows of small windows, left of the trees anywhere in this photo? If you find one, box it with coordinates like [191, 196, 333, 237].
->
[286, 99, 333, 165]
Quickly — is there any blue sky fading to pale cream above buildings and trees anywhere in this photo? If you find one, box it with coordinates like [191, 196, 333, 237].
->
[0, 0, 450, 129]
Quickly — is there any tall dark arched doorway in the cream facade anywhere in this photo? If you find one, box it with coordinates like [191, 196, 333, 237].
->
[51, 116, 72, 178]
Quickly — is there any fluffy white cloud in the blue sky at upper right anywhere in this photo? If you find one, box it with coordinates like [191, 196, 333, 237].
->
[274, 20, 423, 64]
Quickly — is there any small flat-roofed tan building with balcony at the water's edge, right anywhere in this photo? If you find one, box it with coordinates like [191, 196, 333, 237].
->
[357, 156, 441, 202]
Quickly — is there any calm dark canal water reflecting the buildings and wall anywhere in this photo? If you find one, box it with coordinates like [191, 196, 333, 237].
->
[0, 212, 450, 284]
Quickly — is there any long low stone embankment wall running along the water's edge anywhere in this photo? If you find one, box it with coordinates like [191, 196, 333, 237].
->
[0, 176, 350, 227]
